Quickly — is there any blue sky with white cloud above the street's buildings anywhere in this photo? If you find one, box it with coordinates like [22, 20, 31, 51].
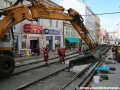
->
[52, 0, 120, 32]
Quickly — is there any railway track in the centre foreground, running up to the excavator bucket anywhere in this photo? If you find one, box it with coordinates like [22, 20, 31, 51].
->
[16, 64, 92, 90]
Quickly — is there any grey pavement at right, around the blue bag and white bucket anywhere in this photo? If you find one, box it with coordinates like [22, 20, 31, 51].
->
[91, 47, 120, 90]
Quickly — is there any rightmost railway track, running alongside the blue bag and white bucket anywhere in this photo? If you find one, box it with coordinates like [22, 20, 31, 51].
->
[59, 47, 109, 90]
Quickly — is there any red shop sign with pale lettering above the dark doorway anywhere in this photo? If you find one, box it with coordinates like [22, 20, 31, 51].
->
[24, 24, 42, 34]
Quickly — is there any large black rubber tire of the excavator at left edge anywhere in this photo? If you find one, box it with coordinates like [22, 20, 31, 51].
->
[0, 55, 15, 78]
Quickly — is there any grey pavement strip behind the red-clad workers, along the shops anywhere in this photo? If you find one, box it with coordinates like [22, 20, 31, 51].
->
[14, 48, 77, 62]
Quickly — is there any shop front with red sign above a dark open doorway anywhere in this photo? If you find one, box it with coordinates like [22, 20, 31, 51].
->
[22, 24, 43, 54]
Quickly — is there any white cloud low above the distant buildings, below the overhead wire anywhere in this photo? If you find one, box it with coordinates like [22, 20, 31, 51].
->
[100, 17, 120, 32]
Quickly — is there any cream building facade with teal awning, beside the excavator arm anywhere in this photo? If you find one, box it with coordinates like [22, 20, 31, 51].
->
[63, 21, 81, 48]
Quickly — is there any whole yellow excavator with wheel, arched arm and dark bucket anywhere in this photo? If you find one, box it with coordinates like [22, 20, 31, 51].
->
[0, 0, 101, 78]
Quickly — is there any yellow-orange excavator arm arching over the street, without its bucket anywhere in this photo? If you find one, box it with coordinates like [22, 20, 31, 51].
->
[0, 3, 96, 50]
